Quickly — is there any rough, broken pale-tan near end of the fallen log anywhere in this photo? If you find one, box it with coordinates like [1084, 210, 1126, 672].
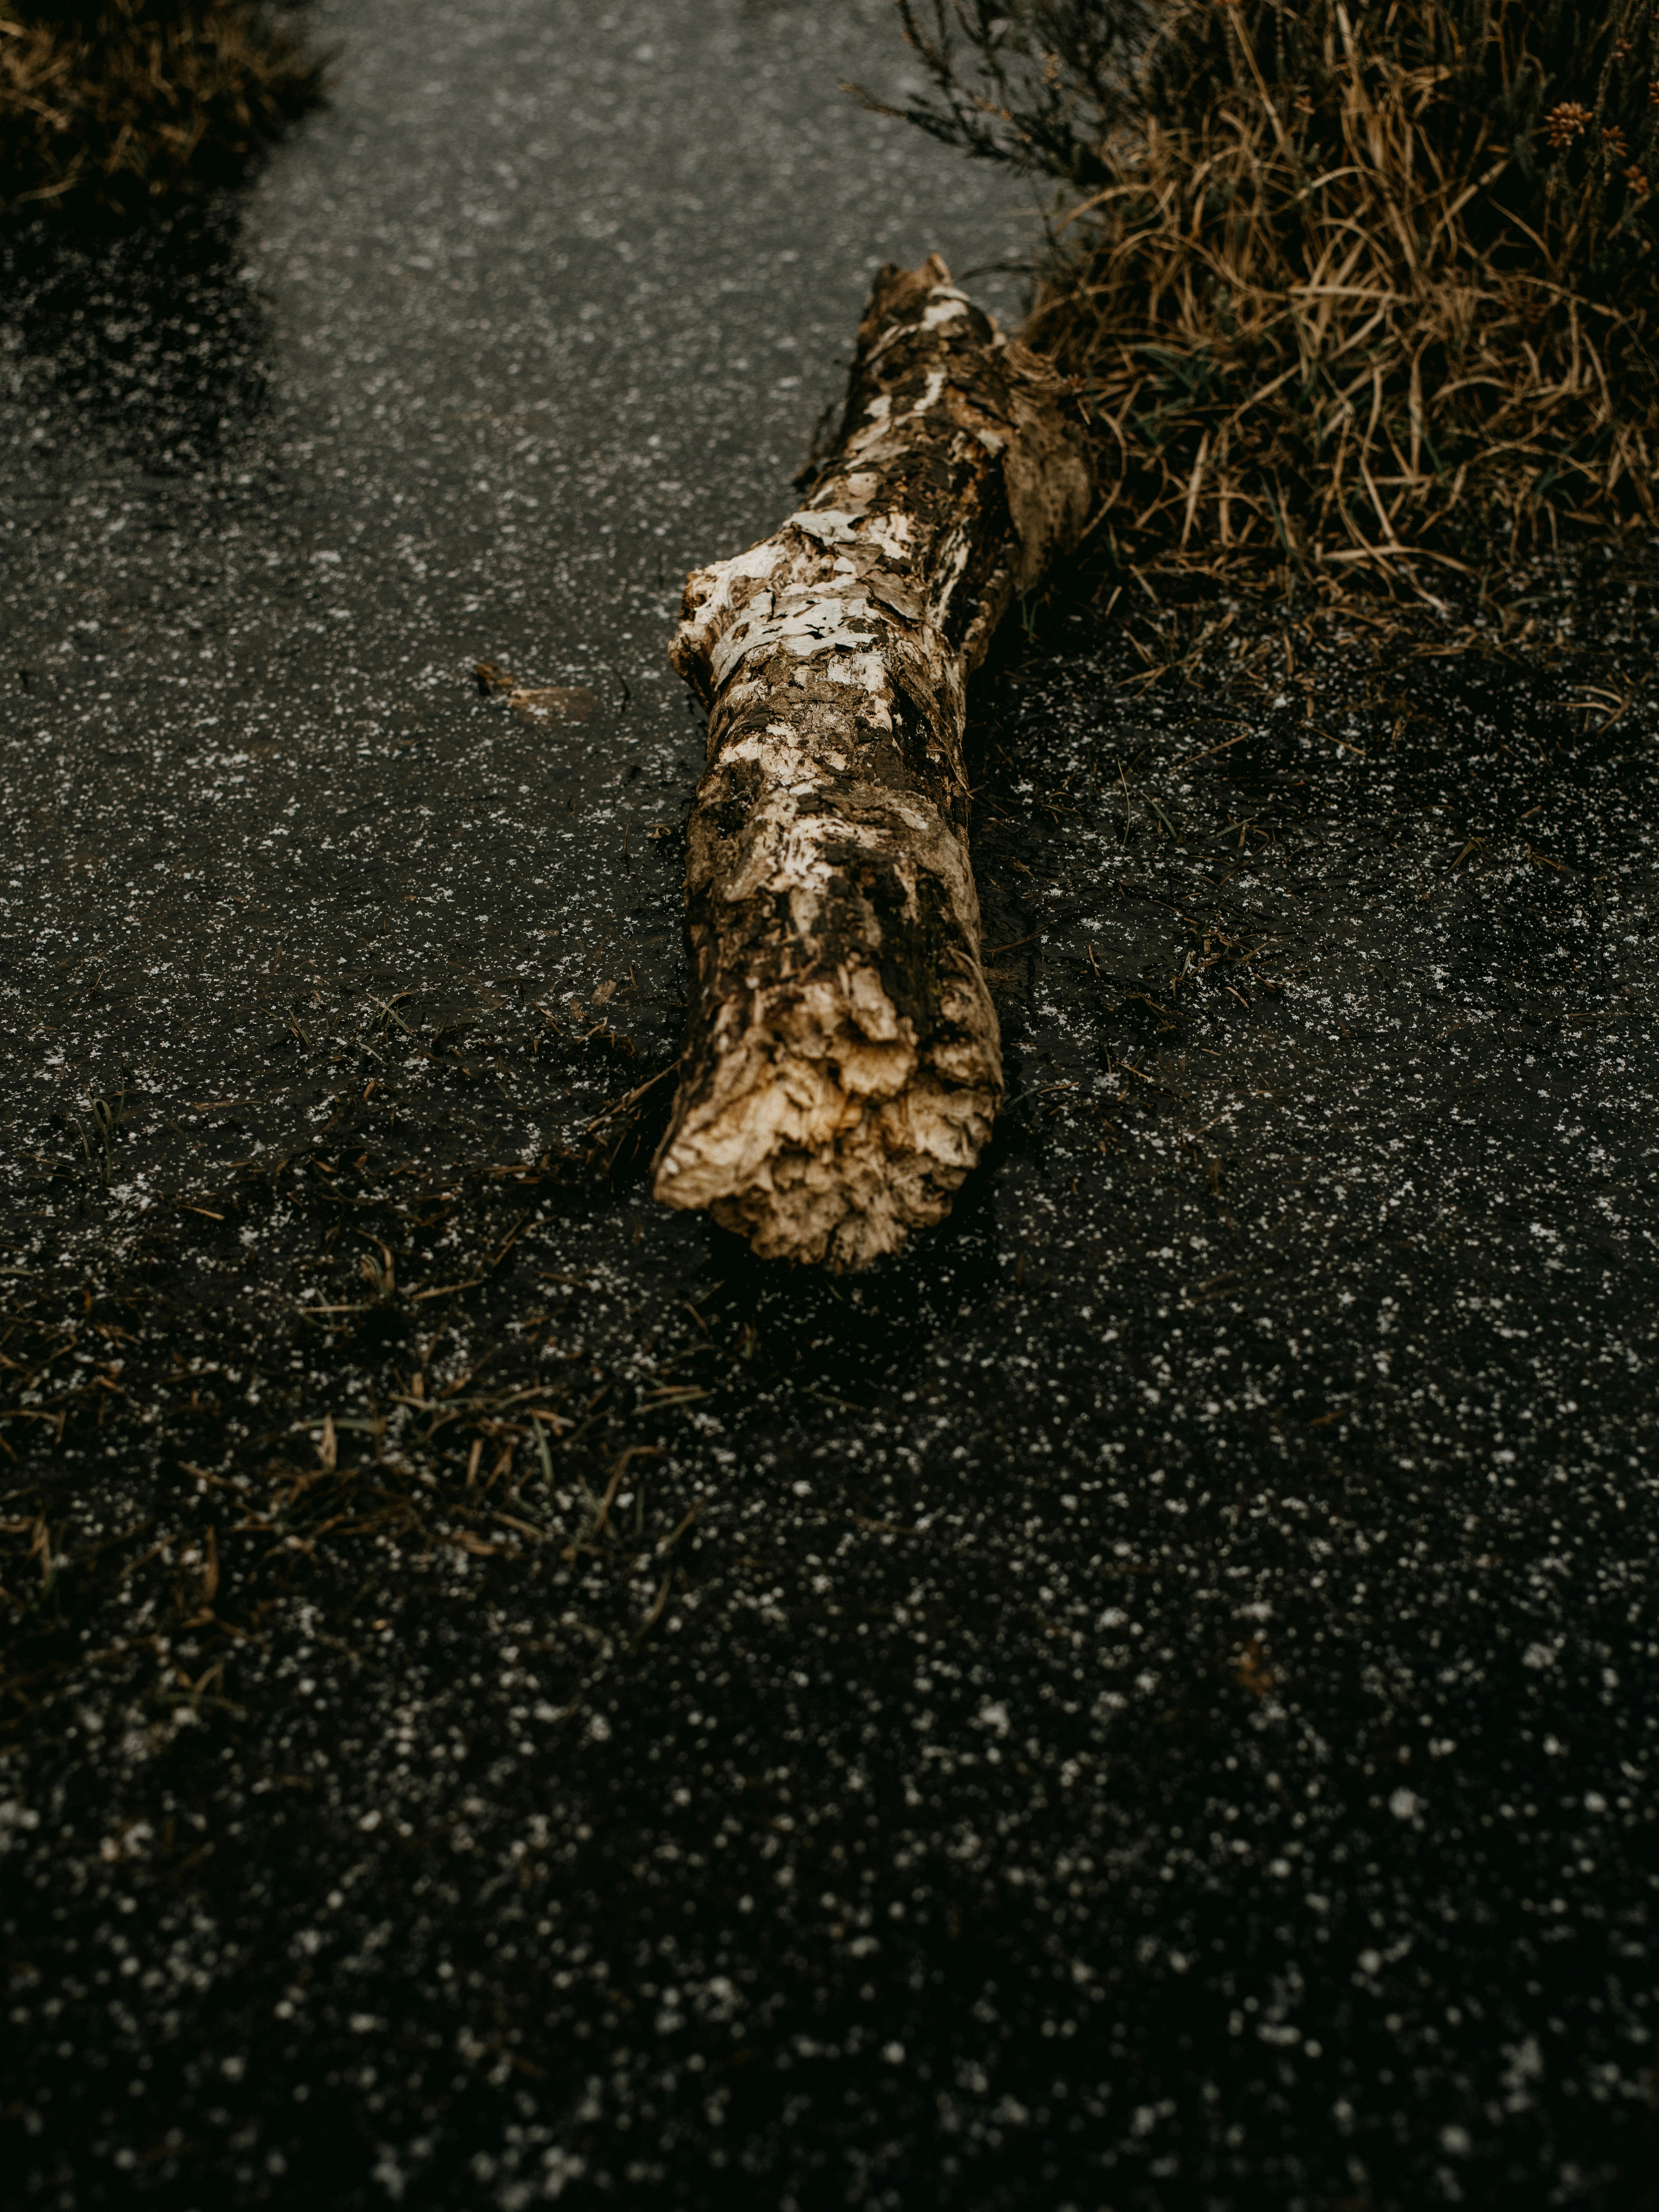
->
[655, 967, 1002, 1270]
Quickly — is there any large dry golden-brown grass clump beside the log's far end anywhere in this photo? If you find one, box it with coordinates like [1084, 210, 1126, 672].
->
[898, 0, 1659, 588]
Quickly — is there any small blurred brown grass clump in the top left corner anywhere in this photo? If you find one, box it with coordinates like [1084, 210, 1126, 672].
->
[0, 0, 321, 217]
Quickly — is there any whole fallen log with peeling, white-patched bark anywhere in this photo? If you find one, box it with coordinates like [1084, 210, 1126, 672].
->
[655, 254, 1093, 1270]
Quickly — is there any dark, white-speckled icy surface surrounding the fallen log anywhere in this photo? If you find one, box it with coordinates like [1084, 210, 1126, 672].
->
[0, 0, 1659, 2212]
